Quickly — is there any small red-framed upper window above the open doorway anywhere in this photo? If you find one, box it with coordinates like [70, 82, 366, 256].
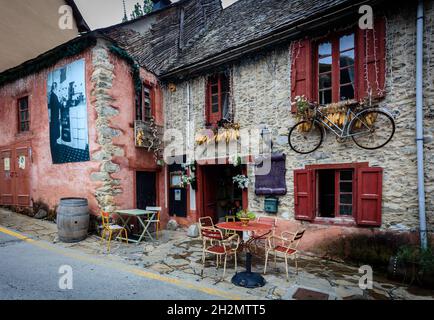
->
[206, 73, 230, 125]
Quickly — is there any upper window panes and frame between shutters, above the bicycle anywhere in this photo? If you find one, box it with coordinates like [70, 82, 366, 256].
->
[317, 33, 356, 104]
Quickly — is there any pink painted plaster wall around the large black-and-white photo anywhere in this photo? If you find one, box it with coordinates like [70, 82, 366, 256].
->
[0, 43, 168, 221]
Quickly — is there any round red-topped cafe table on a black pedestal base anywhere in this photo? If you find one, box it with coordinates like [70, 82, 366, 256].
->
[217, 221, 272, 288]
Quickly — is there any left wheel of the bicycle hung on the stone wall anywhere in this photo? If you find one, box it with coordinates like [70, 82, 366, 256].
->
[288, 120, 324, 154]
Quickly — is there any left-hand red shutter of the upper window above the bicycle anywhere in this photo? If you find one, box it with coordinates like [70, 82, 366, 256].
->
[291, 39, 313, 112]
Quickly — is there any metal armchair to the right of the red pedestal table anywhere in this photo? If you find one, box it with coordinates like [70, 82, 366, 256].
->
[264, 229, 306, 280]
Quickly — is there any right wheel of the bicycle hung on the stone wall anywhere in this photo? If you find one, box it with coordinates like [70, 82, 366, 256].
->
[349, 109, 395, 150]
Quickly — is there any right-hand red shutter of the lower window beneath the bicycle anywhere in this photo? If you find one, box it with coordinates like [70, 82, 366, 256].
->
[356, 168, 383, 227]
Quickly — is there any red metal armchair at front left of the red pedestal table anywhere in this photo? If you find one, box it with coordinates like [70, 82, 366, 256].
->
[200, 227, 240, 278]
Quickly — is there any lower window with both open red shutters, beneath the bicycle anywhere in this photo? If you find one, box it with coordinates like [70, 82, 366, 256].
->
[294, 163, 383, 226]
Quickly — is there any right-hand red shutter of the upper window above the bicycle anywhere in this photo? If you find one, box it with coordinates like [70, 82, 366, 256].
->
[356, 17, 386, 100]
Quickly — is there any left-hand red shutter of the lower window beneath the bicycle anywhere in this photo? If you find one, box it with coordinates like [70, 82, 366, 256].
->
[294, 170, 315, 221]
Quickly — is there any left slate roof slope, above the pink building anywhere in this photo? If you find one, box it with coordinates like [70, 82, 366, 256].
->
[99, 0, 223, 75]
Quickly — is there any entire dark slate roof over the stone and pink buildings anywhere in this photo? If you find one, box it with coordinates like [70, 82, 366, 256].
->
[103, 0, 361, 76]
